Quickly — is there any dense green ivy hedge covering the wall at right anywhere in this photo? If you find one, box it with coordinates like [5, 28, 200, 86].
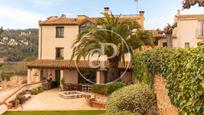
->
[133, 47, 204, 114]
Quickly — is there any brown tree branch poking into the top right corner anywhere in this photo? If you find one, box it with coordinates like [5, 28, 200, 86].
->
[183, 0, 204, 9]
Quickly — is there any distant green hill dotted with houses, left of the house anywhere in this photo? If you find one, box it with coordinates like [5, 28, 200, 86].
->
[0, 29, 38, 62]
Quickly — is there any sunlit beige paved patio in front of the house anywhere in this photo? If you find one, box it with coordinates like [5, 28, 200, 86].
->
[11, 89, 102, 111]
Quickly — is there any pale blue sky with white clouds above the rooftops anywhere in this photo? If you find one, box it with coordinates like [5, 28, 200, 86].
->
[0, 0, 204, 29]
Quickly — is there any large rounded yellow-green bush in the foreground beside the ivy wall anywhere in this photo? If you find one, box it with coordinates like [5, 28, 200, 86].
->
[107, 84, 156, 114]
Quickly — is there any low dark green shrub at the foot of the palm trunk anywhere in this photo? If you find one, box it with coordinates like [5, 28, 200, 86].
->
[91, 82, 124, 95]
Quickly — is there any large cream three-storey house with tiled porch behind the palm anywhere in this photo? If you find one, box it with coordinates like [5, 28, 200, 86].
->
[27, 7, 144, 86]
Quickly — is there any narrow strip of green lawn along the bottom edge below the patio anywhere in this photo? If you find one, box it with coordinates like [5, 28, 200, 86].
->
[3, 110, 105, 115]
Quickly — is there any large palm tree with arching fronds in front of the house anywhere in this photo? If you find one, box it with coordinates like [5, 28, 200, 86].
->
[72, 14, 152, 82]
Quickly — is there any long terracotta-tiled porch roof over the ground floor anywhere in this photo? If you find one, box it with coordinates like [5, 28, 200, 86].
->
[27, 59, 132, 69]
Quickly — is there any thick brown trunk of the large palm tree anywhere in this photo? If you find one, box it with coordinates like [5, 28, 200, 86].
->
[107, 57, 120, 82]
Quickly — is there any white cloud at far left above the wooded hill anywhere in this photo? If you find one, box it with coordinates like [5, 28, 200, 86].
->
[0, 5, 45, 28]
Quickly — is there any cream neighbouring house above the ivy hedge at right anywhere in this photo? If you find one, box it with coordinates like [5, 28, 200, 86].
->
[158, 12, 204, 48]
